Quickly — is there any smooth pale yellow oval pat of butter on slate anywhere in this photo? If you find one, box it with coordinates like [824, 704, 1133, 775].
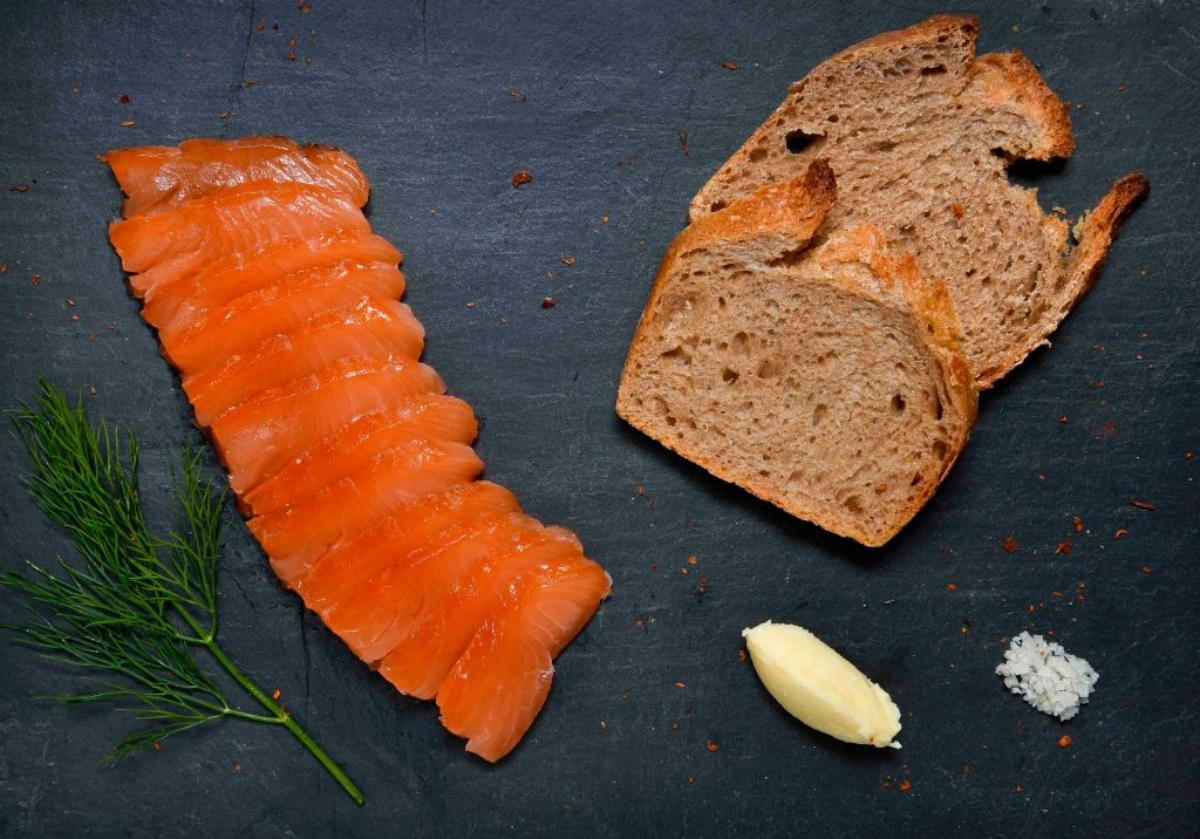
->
[742, 621, 900, 749]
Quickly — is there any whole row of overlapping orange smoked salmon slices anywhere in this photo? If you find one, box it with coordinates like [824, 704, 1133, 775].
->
[104, 137, 611, 762]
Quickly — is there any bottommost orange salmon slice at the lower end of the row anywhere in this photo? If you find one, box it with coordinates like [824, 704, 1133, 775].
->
[438, 559, 612, 762]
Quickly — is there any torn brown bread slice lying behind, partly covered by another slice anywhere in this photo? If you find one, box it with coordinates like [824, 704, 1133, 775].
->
[690, 14, 1148, 388]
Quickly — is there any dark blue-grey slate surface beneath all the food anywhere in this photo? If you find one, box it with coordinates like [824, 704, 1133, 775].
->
[0, 0, 1200, 837]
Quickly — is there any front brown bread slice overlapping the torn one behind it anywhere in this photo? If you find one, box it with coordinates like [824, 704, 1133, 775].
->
[617, 160, 977, 545]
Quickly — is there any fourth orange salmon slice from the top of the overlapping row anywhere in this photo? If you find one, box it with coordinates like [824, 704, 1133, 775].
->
[158, 263, 408, 374]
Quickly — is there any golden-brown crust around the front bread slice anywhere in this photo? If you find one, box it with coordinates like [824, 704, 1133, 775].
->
[617, 161, 978, 547]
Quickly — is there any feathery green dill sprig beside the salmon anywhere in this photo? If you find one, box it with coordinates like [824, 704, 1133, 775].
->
[0, 380, 362, 804]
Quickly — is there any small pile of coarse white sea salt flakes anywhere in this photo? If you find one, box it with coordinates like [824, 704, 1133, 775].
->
[996, 633, 1100, 720]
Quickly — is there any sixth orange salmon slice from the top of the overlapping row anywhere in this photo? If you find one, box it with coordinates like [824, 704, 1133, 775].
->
[211, 360, 445, 495]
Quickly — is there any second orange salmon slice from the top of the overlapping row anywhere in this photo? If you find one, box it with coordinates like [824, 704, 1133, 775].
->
[108, 181, 371, 296]
